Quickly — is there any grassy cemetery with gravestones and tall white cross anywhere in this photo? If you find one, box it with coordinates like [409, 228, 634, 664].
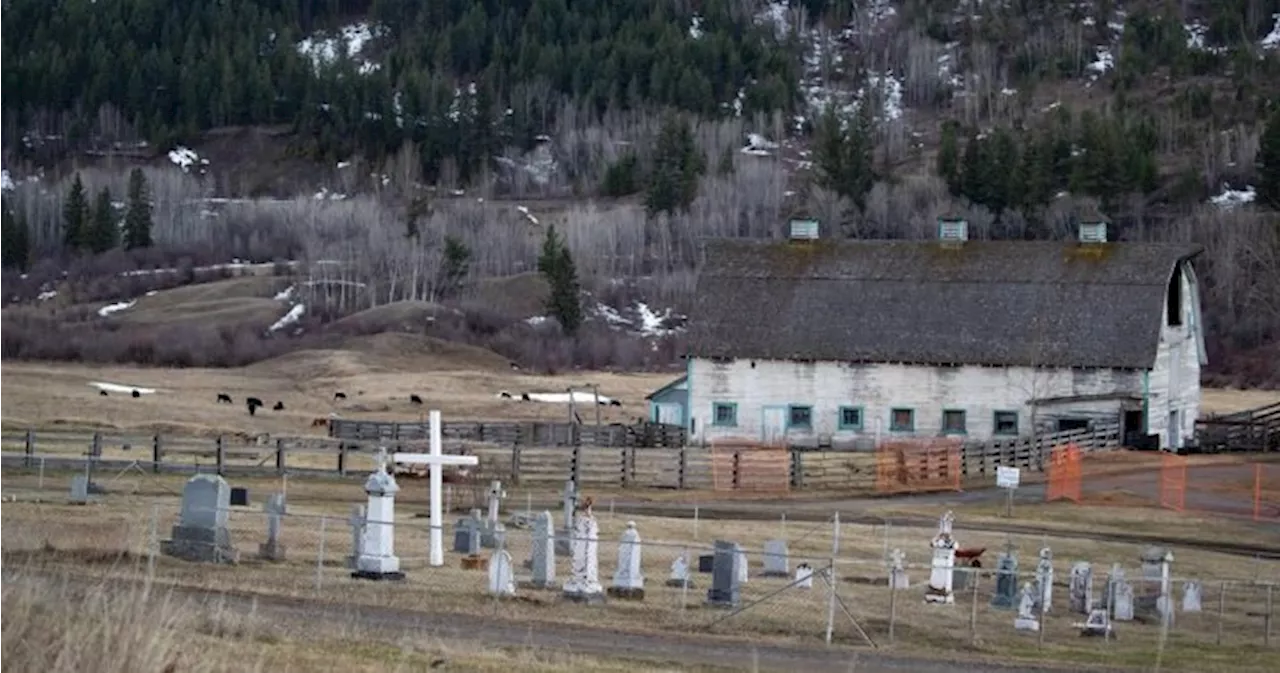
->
[0, 413, 1280, 672]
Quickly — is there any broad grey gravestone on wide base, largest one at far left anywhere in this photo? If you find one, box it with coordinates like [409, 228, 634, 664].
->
[160, 475, 239, 563]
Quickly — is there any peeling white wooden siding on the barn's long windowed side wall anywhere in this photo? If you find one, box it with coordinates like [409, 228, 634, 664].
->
[689, 358, 1142, 445]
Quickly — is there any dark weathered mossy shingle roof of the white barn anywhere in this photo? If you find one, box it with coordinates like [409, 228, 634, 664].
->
[690, 239, 1202, 368]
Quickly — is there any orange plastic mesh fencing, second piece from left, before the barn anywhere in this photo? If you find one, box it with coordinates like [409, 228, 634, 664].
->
[876, 438, 961, 493]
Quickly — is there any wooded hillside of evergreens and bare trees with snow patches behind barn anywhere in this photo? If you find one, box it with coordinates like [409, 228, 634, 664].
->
[0, 0, 1280, 384]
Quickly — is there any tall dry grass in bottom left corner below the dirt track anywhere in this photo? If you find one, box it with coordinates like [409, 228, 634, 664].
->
[0, 568, 712, 673]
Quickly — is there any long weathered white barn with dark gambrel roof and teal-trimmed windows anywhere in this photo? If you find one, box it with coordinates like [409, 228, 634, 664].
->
[684, 220, 1206, 448]
